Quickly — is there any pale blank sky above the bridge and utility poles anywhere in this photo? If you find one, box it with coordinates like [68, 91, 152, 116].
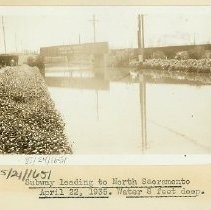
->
[0, 6, 211, 52]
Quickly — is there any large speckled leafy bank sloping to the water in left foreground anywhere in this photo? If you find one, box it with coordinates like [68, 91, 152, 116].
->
[0, 65, 72, 154]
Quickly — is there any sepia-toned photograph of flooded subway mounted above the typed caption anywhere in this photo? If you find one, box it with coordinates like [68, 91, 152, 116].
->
[0, 6, 211, 155]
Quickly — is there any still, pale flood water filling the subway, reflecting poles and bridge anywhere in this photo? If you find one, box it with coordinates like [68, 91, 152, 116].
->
[46, 65, 211, 154]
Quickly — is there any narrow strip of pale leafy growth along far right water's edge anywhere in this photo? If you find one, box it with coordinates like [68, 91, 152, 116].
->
[142, 59, 211, 72]
